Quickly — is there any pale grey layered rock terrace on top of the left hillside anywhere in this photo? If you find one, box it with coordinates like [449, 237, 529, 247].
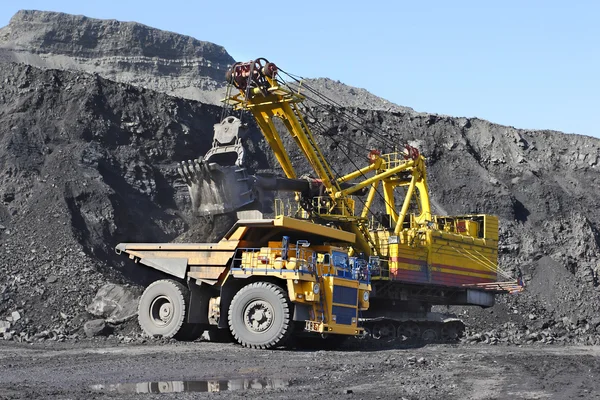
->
[0, 11, 234, 104]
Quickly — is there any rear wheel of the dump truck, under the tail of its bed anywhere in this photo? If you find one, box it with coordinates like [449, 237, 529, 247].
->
[138, 279, 193, 340]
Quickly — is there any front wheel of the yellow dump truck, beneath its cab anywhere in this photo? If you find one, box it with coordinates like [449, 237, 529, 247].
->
[228, 282, 292, 349]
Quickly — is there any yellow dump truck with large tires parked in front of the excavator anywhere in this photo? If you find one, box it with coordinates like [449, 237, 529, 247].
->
[117, 217, 371, 348]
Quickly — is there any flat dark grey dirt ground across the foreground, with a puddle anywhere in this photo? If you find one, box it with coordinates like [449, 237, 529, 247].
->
[0, 342, 600, 399]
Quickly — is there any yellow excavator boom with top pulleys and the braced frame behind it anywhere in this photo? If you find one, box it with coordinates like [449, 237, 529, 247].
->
[220, 58, 440, 256]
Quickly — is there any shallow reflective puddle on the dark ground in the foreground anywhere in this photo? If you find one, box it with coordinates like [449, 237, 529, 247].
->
[90, 378, 289, 393]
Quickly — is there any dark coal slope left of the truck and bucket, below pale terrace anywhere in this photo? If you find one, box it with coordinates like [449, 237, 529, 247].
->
[0, 63, 251, 339]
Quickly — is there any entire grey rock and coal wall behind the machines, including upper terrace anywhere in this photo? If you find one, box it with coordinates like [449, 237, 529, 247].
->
[0, 12, 600, 343]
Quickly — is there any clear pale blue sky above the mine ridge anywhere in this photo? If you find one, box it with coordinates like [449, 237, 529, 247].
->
[0, 0, 600, 137]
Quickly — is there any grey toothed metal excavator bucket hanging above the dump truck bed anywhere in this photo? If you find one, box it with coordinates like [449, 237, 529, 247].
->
[177, 116, 255, 216]
